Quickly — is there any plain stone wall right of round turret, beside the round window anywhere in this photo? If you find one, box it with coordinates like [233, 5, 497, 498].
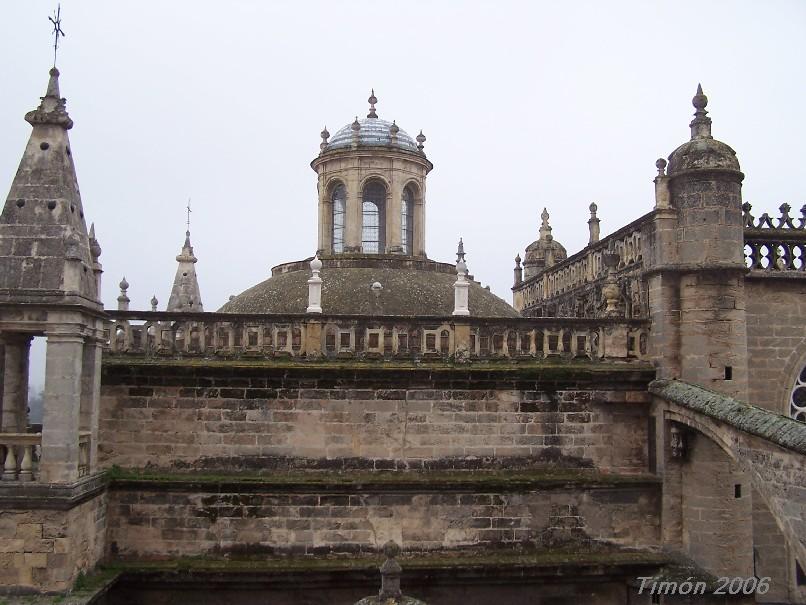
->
[745, 277, 806, 416]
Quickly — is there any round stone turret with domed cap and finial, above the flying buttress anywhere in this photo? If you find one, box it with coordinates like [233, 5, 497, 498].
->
[650, 86, 747, 400]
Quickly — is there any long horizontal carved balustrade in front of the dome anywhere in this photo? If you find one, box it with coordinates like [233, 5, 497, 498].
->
[105, 311, 648, 361]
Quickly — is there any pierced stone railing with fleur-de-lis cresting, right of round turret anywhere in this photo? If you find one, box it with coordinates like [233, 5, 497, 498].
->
[742, 203, 806, 276]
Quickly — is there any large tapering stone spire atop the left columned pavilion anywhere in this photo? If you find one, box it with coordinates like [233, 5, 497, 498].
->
[0, 67, 101, 308]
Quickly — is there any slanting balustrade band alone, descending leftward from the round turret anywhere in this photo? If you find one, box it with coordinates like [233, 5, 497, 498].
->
[516, 213, 653, 316]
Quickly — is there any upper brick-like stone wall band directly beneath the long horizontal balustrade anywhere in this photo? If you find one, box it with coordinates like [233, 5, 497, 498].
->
[99, 364, 652, 473]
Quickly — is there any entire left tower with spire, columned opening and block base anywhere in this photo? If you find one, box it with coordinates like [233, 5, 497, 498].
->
[0, 67, 107, 591]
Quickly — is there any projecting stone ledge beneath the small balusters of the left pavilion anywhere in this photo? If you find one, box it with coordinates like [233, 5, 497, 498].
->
[0, 472, 109, 511]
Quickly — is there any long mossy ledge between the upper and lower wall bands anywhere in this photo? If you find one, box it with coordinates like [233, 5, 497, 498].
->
[110, 469, 662, 494]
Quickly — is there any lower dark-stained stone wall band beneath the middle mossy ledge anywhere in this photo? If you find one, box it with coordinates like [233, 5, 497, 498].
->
[109, 476, 660, 559]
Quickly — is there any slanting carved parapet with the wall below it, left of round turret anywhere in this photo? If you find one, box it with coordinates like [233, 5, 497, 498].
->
[513, 212, 654, 317]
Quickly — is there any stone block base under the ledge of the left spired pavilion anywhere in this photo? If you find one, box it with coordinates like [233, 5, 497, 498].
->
[0, 493, 107, 593]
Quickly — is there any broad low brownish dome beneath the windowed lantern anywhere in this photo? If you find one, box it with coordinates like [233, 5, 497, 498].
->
[219, 255, 519, 317]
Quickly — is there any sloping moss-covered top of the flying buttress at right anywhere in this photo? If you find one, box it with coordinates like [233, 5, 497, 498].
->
[649, 380, 806, 454]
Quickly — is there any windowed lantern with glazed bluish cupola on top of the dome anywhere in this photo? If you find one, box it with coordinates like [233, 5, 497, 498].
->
[311, 90, 434, 257]
